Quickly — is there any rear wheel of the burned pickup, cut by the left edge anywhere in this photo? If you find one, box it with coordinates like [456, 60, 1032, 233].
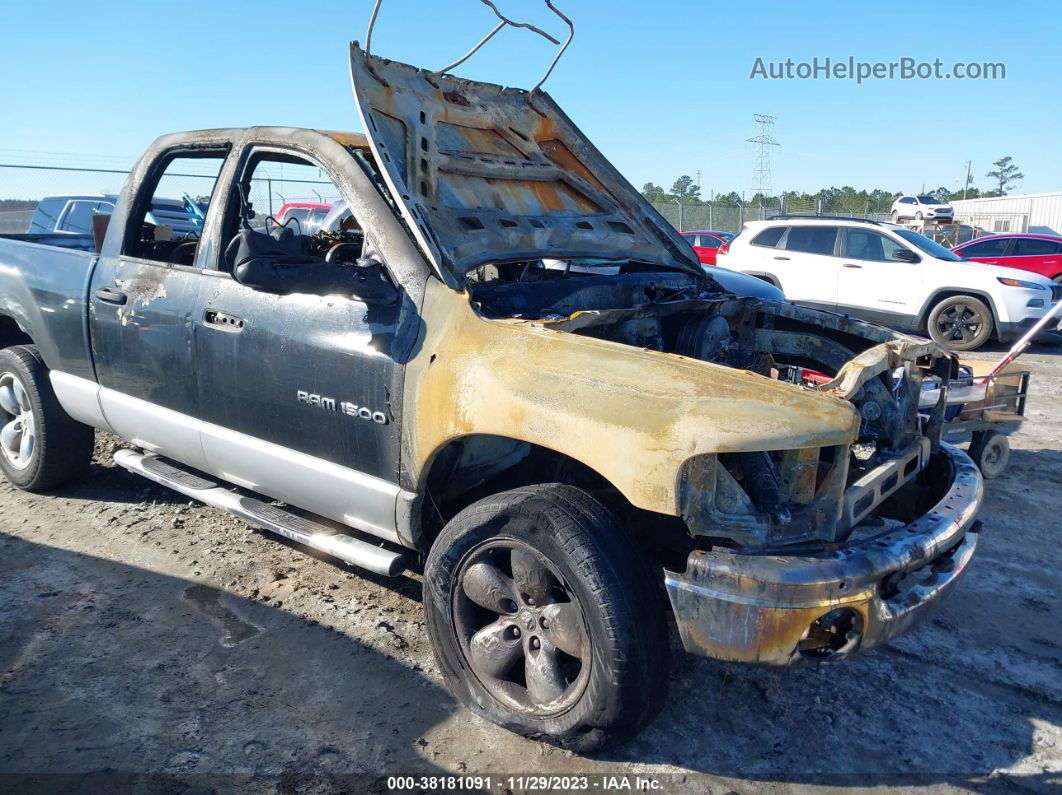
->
[0, 345, 96, 491]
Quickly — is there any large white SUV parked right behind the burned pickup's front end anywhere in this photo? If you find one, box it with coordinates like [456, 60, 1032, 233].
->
[716, 217, 1062, 350]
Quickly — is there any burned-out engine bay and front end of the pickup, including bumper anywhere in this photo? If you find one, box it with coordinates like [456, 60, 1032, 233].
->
[473, 274, 982, 666]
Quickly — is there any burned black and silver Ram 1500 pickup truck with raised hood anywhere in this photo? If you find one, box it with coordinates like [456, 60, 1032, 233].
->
[0, 45, 981, 749]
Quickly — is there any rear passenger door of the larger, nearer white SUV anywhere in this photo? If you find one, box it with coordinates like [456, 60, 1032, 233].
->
[765, 224, 839, 310]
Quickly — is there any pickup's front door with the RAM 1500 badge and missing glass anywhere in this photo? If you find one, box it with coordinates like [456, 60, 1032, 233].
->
[194, 149, 410, 539]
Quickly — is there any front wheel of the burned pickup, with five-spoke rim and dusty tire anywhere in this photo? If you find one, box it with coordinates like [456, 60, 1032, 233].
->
[424, 483, 670, 753]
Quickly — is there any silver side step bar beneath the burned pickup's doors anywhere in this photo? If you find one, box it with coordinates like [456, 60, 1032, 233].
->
[115, 450, 409, 577]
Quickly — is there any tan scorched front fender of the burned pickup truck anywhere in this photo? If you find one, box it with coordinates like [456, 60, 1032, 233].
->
[405, 281, 859, 516]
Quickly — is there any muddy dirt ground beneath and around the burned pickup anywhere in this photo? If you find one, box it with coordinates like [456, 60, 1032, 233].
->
[0, 346, 1062, 793]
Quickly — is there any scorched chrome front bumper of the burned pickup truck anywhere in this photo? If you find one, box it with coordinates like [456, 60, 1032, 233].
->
[665, 445, 983, 666]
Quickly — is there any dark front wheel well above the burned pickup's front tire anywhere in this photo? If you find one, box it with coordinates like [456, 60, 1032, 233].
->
[412, 434, 689, 552]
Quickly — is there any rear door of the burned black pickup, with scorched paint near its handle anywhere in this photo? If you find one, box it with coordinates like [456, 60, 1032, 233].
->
[89, 150, 226, 467]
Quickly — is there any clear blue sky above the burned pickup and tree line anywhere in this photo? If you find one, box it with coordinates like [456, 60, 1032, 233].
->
[0, 0, 1062, 195]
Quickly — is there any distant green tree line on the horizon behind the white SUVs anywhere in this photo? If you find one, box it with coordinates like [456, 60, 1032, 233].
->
[641, 157, 1025, 209]
